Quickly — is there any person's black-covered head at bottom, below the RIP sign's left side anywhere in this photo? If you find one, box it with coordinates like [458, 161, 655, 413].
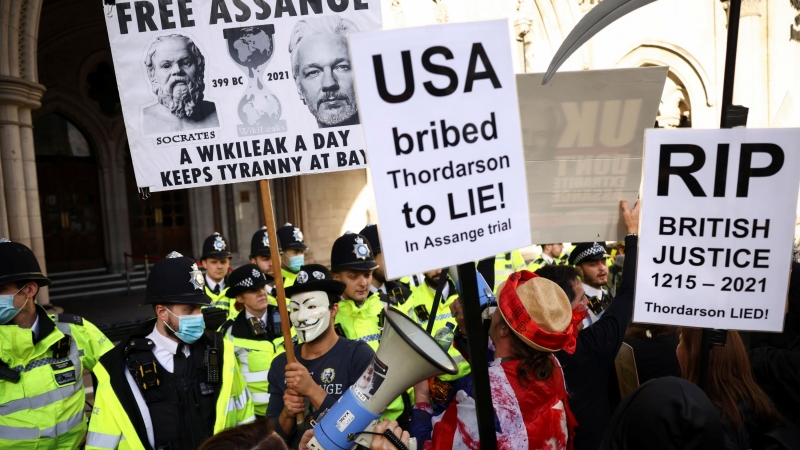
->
[599, 377, 725, 450]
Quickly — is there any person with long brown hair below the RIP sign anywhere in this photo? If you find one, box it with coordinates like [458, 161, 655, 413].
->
[677, 327, 784, 450]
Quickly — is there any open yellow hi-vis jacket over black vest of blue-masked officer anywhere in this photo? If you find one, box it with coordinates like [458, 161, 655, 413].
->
[86, 339, 255, 450]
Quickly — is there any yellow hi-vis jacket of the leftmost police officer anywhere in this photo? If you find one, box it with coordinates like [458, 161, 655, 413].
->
[0, 306, 113, 450]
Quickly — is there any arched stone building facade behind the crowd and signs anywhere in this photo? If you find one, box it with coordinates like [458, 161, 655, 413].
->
[0, 0, 800, 302]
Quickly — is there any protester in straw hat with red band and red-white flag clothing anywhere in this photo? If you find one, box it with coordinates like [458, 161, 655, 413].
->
[411, 271, 582, 449]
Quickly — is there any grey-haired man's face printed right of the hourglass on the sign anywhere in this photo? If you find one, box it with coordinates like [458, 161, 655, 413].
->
[289, 16, 360, 128]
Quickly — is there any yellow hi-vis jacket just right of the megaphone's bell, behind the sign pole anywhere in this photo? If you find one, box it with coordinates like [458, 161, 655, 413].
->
[402, 282, 471, 381]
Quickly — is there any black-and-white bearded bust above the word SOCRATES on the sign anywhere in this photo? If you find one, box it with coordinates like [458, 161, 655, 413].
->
[142, 34, 219, 134]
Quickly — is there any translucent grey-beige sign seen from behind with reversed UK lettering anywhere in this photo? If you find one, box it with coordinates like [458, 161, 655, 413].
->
[517, 67, 667, 244]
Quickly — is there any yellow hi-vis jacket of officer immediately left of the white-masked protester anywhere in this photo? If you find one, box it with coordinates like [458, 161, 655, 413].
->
[220, 312, 286, 416]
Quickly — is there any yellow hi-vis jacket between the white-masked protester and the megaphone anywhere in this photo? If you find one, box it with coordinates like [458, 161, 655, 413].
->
[334, 292, 405, 420]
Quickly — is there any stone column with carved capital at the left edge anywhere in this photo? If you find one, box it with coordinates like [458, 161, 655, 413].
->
[0, 76, 50, 305]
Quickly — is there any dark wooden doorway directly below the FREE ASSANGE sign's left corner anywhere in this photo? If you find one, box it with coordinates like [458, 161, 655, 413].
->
[126, 150, 193, 258]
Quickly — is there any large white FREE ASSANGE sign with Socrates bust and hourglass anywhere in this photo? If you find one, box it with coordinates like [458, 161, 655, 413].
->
[98, 0, 381, 191]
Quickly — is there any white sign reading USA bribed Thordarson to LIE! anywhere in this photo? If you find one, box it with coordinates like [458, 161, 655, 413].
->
[348, 20, 530, 278]
